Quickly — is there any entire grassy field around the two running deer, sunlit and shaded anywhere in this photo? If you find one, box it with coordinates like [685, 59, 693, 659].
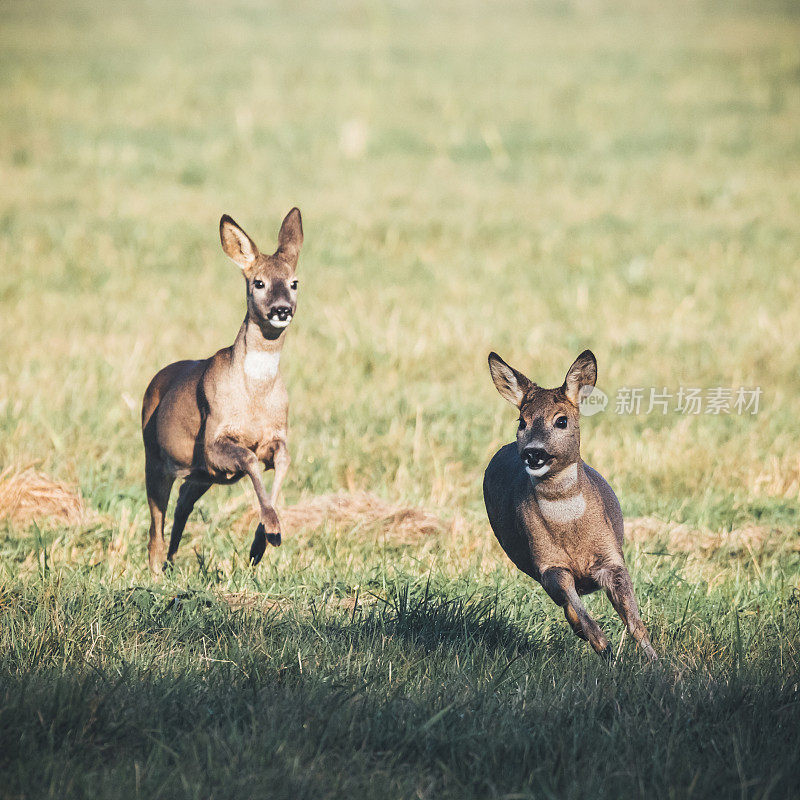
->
[0, 0, 800, 800]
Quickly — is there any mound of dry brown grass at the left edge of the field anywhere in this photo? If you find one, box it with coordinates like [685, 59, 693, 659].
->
[0, 467, 88, 525]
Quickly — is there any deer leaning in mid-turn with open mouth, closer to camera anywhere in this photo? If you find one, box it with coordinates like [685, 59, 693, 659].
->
[483, 350, 657, 661]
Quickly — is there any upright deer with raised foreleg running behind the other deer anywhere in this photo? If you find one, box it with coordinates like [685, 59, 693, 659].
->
[142, 208, 303, 575]
